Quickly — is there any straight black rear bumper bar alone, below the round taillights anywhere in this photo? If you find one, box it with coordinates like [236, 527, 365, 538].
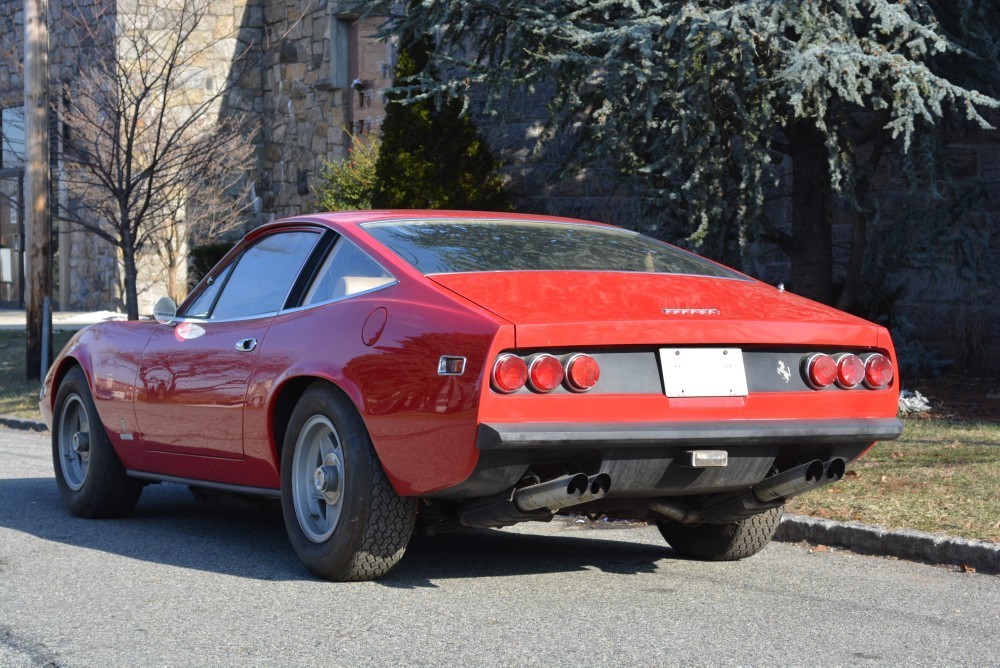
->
[477, 418, 903, 450]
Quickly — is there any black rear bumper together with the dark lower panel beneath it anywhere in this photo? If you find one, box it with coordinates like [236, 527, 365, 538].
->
[429, 418, 903, 499]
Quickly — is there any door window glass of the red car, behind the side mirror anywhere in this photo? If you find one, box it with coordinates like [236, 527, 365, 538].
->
[209, 231, 320, 320]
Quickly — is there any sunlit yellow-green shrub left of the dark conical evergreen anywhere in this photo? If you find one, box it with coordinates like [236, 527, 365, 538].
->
[313, 136, 380, 211]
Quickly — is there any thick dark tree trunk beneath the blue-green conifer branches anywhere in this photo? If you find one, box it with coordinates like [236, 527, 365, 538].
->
[788, 120, 834, 304]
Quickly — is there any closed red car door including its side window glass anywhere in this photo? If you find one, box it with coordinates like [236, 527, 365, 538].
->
[135, 229, 320, 459]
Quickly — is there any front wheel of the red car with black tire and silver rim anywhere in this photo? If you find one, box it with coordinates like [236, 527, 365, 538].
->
[52, 367, 143, 518]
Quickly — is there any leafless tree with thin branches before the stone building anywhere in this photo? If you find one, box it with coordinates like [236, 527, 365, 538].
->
[60, 0, 257, 318]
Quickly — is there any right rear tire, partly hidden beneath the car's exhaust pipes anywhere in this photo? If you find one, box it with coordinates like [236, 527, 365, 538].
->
[656, 506, 784, 561]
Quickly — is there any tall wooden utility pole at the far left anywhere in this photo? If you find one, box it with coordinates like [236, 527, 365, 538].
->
[24, 0, 52, 380]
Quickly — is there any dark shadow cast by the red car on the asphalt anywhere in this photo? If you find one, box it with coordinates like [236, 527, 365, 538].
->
[0, 478, 677, 589]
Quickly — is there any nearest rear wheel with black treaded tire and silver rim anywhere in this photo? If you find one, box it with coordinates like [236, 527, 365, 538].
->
[281, 382, 417, 581]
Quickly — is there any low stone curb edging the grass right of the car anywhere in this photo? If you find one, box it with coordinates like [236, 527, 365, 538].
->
[774, 515, 1000, 573]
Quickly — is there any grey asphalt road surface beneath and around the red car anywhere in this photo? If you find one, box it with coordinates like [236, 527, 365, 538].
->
[0, 430, 1000, 667]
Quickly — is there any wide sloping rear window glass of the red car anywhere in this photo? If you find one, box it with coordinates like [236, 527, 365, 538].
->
[363, 219, 742, 278]
